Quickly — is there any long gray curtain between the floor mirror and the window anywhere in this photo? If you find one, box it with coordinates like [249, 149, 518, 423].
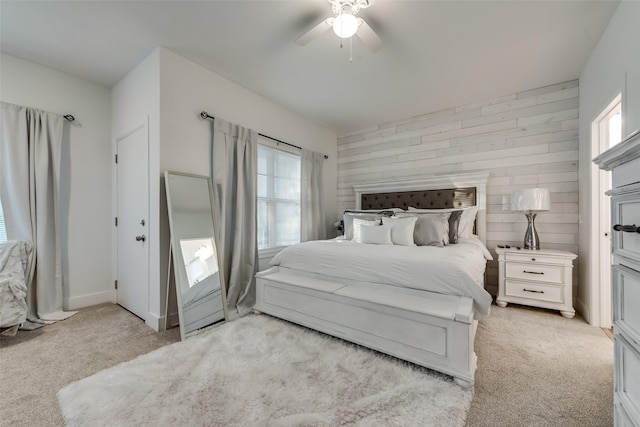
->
[211, 119, 258, 316]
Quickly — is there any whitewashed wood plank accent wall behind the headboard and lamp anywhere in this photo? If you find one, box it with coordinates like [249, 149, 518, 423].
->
[338, 80, 580, 298]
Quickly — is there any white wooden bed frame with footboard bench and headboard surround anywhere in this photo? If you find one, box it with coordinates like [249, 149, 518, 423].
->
[255, 173, 489, 387]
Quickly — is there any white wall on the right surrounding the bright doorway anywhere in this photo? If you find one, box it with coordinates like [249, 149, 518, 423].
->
[579, 1, 640, 326]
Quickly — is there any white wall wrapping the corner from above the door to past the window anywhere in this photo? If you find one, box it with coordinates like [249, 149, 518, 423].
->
[112, 48, 337, 329]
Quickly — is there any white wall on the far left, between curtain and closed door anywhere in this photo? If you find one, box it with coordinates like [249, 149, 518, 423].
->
[0, 53, 114, 309]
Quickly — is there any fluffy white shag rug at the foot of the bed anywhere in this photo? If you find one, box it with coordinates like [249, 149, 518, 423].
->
[58, 315, 473, 427]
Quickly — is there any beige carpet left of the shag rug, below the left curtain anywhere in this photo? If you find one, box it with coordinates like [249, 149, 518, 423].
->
[0, 304, 180, 427]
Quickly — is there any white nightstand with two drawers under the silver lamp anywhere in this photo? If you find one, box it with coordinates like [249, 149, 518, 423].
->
[496, 248, 577, 319]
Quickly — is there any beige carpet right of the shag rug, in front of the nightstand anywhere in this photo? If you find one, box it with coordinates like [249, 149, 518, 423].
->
[467, 304, 613, 427]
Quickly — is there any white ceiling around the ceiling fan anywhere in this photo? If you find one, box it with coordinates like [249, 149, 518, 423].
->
[0, 0, 618, 132]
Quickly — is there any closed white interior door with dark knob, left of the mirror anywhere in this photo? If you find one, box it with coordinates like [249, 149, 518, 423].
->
[116, 125, 149, 320]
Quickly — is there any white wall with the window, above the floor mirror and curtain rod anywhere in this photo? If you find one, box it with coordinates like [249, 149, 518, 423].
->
[160, 49, 337, 294]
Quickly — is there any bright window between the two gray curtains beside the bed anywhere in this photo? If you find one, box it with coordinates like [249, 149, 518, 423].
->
[258, 144, 300, 249]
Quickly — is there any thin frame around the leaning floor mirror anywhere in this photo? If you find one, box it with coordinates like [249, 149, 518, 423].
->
[164, 170, 229, 341]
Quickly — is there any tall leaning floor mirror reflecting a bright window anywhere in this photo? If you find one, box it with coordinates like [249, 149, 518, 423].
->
[164, 171, 227, 340]
